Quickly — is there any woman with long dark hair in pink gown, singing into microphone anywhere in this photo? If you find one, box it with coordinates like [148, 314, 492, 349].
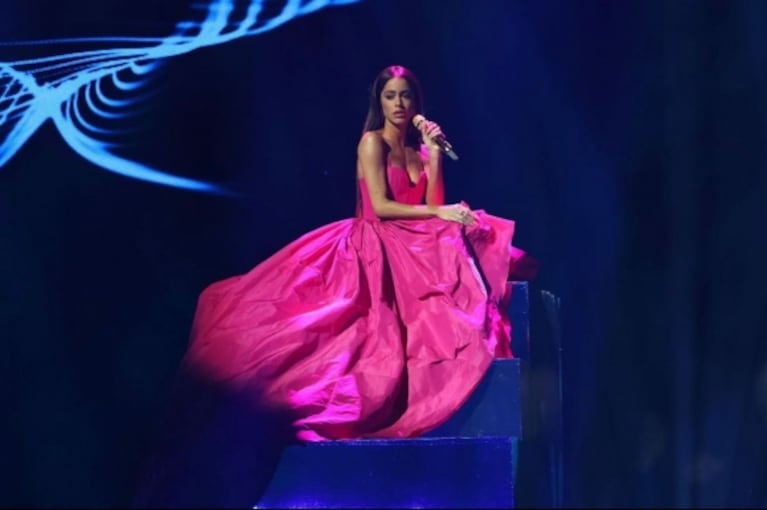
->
[135, 66, 532, 503]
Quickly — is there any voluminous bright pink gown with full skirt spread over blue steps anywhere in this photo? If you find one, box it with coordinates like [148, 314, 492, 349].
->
[177, 166, 514, 441]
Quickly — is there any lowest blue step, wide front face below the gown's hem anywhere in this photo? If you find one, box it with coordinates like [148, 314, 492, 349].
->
[255, 437, 517, 508]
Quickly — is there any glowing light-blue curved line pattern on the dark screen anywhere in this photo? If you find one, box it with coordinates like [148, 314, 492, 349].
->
[0, 0, 360, 193]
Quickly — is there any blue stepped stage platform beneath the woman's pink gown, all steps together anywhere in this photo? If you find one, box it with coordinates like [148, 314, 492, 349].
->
[256, 282, 530, 508]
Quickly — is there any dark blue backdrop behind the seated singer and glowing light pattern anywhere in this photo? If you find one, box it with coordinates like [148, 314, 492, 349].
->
[0, 0, 767, 506]
